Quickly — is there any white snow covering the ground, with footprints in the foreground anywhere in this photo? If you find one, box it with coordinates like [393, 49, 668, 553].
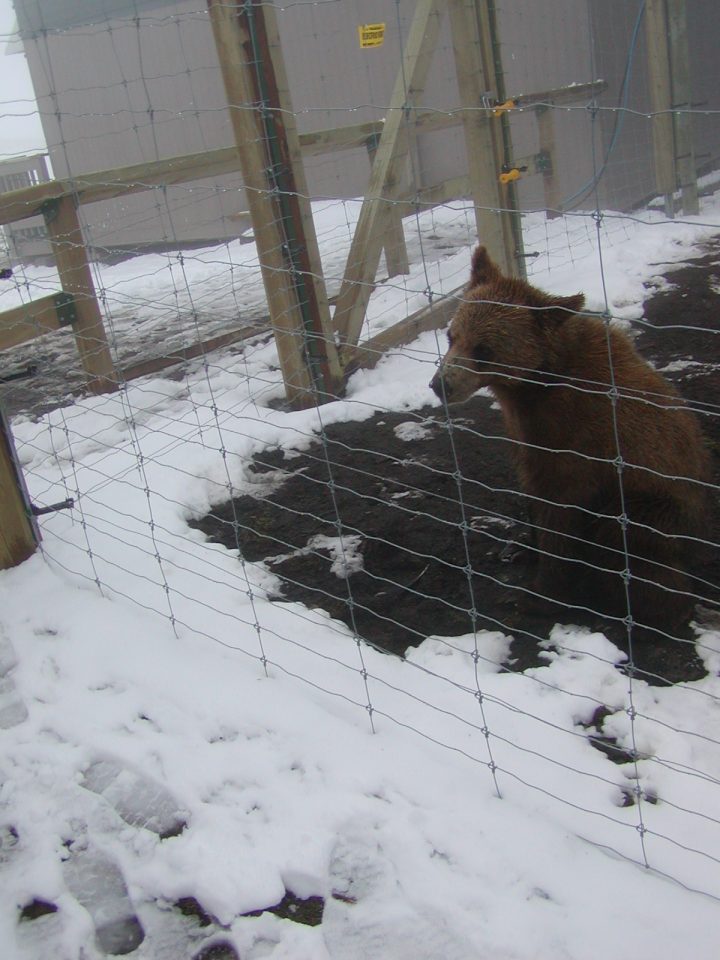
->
[0, 199, 720, 960]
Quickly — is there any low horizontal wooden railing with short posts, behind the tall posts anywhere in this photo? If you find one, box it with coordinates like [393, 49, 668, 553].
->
[0, 81, 605, 392]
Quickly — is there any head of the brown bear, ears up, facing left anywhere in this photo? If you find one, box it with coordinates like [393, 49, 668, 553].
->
[430, 246, 585, 403]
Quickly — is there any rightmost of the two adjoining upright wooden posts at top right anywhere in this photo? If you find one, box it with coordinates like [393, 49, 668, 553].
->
[667, 0, 700, 216]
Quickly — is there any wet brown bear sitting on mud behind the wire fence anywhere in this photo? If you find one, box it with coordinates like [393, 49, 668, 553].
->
[430, 246, 709, 635]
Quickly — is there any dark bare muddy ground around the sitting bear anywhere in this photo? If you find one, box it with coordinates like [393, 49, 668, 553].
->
[197, 244, 720, 683]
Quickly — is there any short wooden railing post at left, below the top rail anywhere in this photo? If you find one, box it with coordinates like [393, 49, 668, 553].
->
[43, 197, 117, 393]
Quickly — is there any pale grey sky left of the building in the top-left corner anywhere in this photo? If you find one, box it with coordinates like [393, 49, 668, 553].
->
[0, 0, 45, 160]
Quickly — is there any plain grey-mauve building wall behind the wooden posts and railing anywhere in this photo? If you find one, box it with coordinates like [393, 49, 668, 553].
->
[9, 0, 720, 256]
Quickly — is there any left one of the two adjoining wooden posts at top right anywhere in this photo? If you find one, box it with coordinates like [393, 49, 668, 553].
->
[645, 0, 677, 217]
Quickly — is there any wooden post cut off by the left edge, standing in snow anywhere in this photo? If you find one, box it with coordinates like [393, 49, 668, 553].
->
[0, 410, 40, 570]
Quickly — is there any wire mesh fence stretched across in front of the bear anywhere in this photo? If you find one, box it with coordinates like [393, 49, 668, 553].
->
[0, 0, 720, 948]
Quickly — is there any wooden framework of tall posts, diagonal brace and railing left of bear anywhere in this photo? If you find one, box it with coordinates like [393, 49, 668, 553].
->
[0, 0, 640, 416]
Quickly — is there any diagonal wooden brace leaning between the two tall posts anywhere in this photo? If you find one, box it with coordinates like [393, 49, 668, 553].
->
[335, 0, 444, 352]
